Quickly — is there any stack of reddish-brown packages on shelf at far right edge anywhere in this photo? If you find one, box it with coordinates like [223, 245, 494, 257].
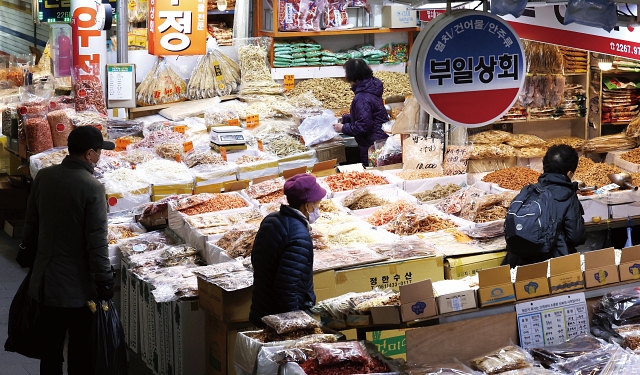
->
[602, 78, 640, 123]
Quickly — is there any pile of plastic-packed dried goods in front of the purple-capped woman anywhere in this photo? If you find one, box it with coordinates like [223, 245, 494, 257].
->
[235, 311, 399, 375]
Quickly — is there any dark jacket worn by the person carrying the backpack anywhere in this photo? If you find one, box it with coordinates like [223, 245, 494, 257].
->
[502, 173, 586, 268]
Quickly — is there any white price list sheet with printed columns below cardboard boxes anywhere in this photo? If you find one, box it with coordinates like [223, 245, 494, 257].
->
[516, 293, 589, 349]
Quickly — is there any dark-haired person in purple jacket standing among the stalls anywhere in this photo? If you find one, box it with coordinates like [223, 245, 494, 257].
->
[333, 59, 389, 166]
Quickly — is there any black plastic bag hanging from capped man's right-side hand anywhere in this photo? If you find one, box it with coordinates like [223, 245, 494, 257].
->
[89, 300, 129, 375]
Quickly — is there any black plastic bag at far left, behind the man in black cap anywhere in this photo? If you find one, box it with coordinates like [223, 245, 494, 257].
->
[4, 271, 42, 359]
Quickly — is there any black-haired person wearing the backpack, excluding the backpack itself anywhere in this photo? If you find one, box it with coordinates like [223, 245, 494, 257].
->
[502, 145, 586, 268]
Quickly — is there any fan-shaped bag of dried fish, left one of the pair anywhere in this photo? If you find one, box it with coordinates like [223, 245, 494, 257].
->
[136, 57, 187, 106]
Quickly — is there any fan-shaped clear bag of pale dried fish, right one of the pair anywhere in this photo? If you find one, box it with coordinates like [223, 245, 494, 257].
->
[187, 38, 240, 100]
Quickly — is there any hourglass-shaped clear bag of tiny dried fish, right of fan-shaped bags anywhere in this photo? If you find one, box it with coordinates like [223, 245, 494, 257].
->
[234, 37, 283, 96]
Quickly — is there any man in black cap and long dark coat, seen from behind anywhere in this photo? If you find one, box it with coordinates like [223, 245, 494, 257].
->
[23, 126, 115, 375]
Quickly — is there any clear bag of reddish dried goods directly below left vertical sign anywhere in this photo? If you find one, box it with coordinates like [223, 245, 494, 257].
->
[71, 64, 107, 116]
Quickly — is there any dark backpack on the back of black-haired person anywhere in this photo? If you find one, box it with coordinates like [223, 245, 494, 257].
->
[504, 184, 558, 256]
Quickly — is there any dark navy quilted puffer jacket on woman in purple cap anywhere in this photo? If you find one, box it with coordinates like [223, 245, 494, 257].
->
[249, 205, 316, 327]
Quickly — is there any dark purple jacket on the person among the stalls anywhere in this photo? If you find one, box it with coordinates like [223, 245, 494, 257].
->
[342, 77, 389, 166]
